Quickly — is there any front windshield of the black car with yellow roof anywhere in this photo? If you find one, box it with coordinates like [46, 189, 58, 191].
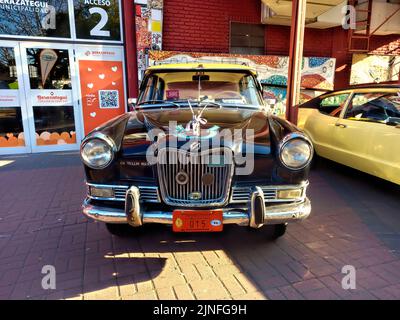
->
[138, 71, 263, 108]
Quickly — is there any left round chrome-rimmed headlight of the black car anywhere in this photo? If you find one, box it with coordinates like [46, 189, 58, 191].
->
[81, 139, 114, 169]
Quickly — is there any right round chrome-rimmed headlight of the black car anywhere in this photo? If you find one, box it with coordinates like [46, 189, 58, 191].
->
[280, 138, 313, 170]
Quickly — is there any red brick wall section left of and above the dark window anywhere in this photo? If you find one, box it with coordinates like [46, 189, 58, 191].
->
[163, 0, 261, 52]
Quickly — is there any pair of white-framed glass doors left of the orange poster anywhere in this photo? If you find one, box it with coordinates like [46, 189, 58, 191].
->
[0, 41, 82, 154]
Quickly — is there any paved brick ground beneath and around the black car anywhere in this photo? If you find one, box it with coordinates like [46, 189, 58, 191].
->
[0, 153, 400, 299]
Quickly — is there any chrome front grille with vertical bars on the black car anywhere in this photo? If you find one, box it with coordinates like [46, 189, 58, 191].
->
[158, 148, 233, 207]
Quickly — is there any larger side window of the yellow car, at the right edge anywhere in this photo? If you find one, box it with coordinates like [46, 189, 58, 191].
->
[344, 92, 400, 123]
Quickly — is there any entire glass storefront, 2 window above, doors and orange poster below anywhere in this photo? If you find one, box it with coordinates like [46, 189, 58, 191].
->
[0, 0, 125, 155]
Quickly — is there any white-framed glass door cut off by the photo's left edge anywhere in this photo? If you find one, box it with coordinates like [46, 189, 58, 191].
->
[0, 41, 31, 154]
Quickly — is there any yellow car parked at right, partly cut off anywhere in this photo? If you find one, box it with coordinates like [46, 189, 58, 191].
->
[298, 85, 400, 184]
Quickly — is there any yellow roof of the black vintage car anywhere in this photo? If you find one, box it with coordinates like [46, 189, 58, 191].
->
[147, 62, 257, 75]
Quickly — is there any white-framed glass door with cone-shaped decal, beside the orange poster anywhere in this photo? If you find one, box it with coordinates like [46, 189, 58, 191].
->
[20, 43, 82, 152]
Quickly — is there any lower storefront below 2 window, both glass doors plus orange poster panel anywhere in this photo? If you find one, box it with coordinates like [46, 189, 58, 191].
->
[0, 41, 126, 155]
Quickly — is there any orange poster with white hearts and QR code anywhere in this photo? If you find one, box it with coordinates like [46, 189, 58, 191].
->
[79, 47, 125, 134]
